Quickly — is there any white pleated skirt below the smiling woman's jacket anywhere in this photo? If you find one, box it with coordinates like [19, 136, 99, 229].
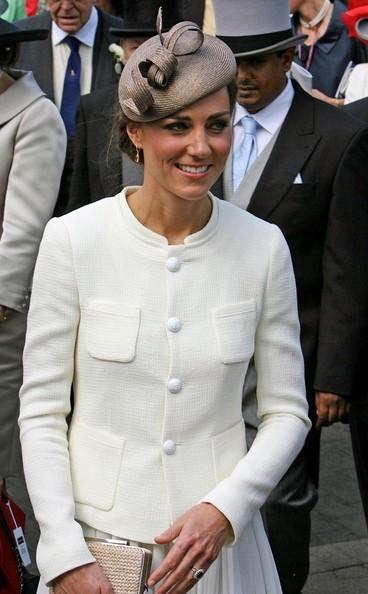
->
[37, 513, 282, 594]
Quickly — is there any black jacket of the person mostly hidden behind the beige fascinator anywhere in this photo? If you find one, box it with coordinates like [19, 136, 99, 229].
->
[67, 85, 143, 211]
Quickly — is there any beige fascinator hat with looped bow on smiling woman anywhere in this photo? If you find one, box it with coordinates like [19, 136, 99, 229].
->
[119, 12, 236, 122]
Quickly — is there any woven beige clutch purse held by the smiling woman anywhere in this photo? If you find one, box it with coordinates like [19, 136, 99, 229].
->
[50, 537, 152, 594]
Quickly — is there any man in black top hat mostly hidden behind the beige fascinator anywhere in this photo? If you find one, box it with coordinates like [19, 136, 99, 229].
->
[67, 0, 183, 211]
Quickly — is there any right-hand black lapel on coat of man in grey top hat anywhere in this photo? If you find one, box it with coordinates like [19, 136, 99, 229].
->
[248, 84, 320, 220]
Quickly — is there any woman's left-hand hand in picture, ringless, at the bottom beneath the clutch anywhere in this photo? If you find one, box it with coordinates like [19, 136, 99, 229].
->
[52, 563, 113, 594]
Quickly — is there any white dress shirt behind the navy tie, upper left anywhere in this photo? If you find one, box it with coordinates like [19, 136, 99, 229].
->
[51, 7, 98, 109]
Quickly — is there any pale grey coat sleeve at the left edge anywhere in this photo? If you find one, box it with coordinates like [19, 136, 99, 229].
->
[0, 97, 66, 311]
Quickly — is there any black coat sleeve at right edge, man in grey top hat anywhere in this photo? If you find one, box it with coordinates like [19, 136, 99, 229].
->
[314, 127, 368, 398]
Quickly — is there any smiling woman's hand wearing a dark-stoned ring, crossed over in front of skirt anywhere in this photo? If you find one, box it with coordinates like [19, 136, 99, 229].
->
[148, 503, 232, 594]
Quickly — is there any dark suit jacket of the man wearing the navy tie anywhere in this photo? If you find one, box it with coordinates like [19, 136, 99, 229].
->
[16, 9, 123, 101]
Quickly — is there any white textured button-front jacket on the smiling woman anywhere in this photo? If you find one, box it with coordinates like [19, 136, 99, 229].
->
[20, 192, 309, 582]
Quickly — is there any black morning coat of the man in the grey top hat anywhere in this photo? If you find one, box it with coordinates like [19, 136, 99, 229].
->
[214, 85, 368, 408]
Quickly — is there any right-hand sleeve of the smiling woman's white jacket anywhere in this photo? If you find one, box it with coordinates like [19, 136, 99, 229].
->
[202, 227, 310, 542]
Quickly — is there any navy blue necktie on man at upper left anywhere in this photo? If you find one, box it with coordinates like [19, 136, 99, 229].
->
[60, 35, 81, 138]
